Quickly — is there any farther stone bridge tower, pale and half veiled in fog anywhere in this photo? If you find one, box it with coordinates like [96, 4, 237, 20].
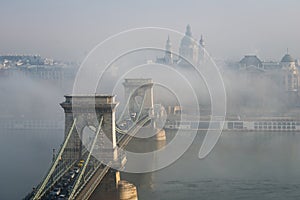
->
[123, 78, 153, 119]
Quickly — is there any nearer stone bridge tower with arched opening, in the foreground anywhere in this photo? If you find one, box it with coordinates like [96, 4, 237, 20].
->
[60, 94, 118, 160]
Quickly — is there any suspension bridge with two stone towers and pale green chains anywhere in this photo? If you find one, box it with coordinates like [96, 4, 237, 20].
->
[24, 79, 157, 200]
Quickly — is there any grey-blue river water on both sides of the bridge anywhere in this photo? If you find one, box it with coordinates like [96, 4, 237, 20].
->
[0, 131, 300, 200]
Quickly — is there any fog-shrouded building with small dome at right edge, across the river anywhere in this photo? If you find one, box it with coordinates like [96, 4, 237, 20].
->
[238, 52, 300, 107]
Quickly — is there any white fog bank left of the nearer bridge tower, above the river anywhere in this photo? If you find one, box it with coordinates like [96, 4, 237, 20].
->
[0, 74, 64, 119]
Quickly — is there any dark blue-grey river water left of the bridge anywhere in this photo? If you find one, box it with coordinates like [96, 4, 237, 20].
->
[0, 130, 64, 200]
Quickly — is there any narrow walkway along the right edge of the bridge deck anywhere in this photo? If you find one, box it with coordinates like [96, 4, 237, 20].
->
[65, 116, 151, 200]
